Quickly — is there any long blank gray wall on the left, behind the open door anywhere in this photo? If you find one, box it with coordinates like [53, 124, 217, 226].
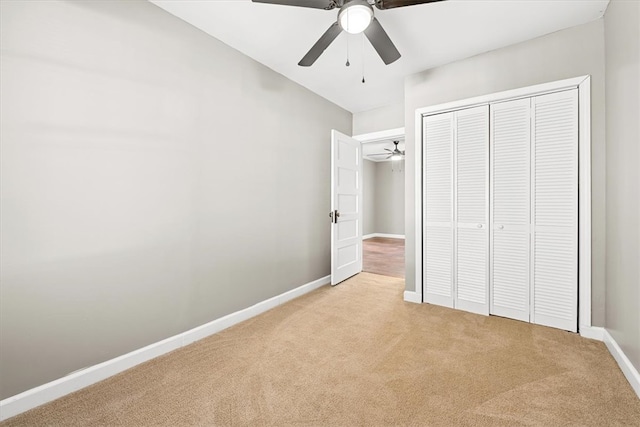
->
[0, 1, 352, 398]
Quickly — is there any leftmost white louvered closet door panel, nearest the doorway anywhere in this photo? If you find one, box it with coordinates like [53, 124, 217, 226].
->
[422, 113, 454, 307]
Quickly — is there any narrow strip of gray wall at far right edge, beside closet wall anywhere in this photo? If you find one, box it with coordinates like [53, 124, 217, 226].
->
[604, 0, 640, 371]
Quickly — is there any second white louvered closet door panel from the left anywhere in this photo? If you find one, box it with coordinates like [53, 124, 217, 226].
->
[454, 105, 489, 314]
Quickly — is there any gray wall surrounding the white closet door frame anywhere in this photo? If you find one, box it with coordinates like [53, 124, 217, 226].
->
[405, 19, 605, 326]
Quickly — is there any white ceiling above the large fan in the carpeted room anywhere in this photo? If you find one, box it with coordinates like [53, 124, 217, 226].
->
[150, 0, 609, 113]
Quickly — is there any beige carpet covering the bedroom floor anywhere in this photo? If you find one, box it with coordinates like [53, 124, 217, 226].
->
[1, 273, 640, 427]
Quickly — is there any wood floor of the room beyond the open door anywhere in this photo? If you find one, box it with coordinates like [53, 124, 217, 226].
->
[362, 237, 404, 278]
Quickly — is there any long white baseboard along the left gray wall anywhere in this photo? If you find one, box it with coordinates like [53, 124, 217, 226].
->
[0, 276, 331, 421]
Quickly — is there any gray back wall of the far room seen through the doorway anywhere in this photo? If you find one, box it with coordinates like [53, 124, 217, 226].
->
[375, 162, 404, 235]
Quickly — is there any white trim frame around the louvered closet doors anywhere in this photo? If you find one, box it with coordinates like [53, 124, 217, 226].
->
[412, 75, 592, 333]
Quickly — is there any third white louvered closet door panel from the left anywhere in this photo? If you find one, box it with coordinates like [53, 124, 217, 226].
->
[490, 98, 531, 322]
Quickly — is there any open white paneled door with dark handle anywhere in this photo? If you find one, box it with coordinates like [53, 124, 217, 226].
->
[330, 130, 362, 285]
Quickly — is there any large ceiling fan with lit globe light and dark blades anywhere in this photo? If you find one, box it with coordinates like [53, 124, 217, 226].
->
[252, 0, 444, 67]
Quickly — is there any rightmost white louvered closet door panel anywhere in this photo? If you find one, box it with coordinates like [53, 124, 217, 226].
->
[531, 89, 578, 332]
